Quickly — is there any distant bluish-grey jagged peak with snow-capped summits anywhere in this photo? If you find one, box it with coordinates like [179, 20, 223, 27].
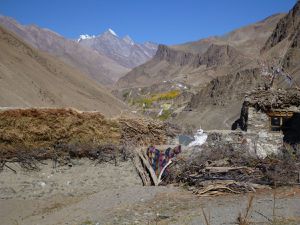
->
[78, 29, 157, 69]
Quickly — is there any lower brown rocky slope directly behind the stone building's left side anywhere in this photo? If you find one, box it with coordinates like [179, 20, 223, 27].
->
[172, 68, 268, 130]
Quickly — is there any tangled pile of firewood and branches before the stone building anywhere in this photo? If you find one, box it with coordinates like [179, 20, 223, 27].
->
[166, 146, 300, 196]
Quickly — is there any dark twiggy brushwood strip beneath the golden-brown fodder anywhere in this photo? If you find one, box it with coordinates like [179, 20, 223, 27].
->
[0, 143, 133, 172]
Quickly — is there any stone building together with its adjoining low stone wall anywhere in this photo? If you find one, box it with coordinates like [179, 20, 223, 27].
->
[188, 88, 300, 158]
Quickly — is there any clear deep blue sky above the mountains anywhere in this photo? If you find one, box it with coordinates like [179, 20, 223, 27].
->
[0, 0, 296, 44]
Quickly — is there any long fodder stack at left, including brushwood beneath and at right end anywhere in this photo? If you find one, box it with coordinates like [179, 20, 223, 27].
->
[0, 108, 175, 168]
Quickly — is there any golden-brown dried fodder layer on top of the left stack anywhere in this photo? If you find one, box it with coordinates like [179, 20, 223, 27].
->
[0, 108, 121, 149]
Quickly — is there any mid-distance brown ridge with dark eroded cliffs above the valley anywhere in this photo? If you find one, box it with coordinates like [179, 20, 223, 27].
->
[116, 44, 253, 88]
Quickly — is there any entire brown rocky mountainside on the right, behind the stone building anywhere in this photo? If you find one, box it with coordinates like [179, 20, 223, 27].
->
[117, 8, 300, 130]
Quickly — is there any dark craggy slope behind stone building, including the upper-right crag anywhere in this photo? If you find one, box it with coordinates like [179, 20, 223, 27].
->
[174, 1, 300, 129]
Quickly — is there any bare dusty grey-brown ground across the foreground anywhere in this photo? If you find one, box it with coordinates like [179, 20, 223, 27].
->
[0, 159, 300, 225]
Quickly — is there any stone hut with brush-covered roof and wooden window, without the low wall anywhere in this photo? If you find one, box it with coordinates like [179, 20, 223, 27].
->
[232, 89, 300, 157]
